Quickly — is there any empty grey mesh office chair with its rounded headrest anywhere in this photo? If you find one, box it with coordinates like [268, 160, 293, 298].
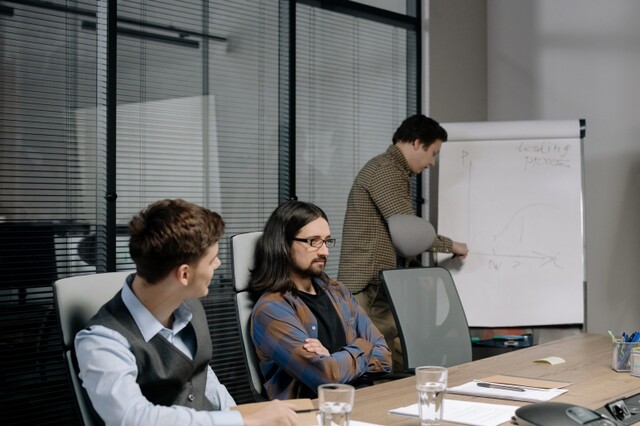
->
[380, 215, 472, 372]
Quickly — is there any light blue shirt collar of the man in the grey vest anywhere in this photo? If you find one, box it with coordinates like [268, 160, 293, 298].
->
[122, 274, 193, 342]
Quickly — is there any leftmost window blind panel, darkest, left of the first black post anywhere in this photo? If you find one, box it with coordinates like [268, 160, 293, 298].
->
[0, 0, 100, 425]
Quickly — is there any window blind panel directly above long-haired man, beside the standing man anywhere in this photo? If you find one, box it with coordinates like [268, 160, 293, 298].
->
[296, 4, 417, 278]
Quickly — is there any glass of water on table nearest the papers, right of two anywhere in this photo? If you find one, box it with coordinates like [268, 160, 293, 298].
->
[416, 366, 448, 426]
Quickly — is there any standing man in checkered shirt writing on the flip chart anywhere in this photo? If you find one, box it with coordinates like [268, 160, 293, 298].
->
[338, 114, 468, 371]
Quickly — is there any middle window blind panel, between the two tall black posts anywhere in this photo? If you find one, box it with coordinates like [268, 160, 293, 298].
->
[116, 0, 279, 402]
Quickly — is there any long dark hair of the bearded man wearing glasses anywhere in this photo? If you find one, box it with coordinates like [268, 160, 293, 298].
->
[249, 201, 329, 295]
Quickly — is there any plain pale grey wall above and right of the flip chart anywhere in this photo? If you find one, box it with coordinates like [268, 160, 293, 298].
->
[426, 0, 640, 333]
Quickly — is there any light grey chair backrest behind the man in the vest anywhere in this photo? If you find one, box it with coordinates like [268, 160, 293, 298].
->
[53, 271, 133, 426]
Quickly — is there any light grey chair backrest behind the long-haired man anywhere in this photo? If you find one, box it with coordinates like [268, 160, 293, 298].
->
[231, 232, 266, 401]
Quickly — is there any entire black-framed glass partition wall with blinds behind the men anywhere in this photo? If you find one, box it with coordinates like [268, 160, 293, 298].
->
[0, 0, 420, 425]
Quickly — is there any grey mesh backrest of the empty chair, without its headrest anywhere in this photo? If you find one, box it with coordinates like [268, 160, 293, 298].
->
[381, 267, 471, 371]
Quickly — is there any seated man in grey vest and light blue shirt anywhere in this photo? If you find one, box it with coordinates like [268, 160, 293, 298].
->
[75, 200, 297, 426]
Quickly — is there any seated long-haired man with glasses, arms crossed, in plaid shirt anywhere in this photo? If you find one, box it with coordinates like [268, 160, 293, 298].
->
[250, 201, 391, 399]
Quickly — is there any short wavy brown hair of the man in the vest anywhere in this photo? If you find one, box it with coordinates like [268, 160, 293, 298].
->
[129, 200, 224, 284]
